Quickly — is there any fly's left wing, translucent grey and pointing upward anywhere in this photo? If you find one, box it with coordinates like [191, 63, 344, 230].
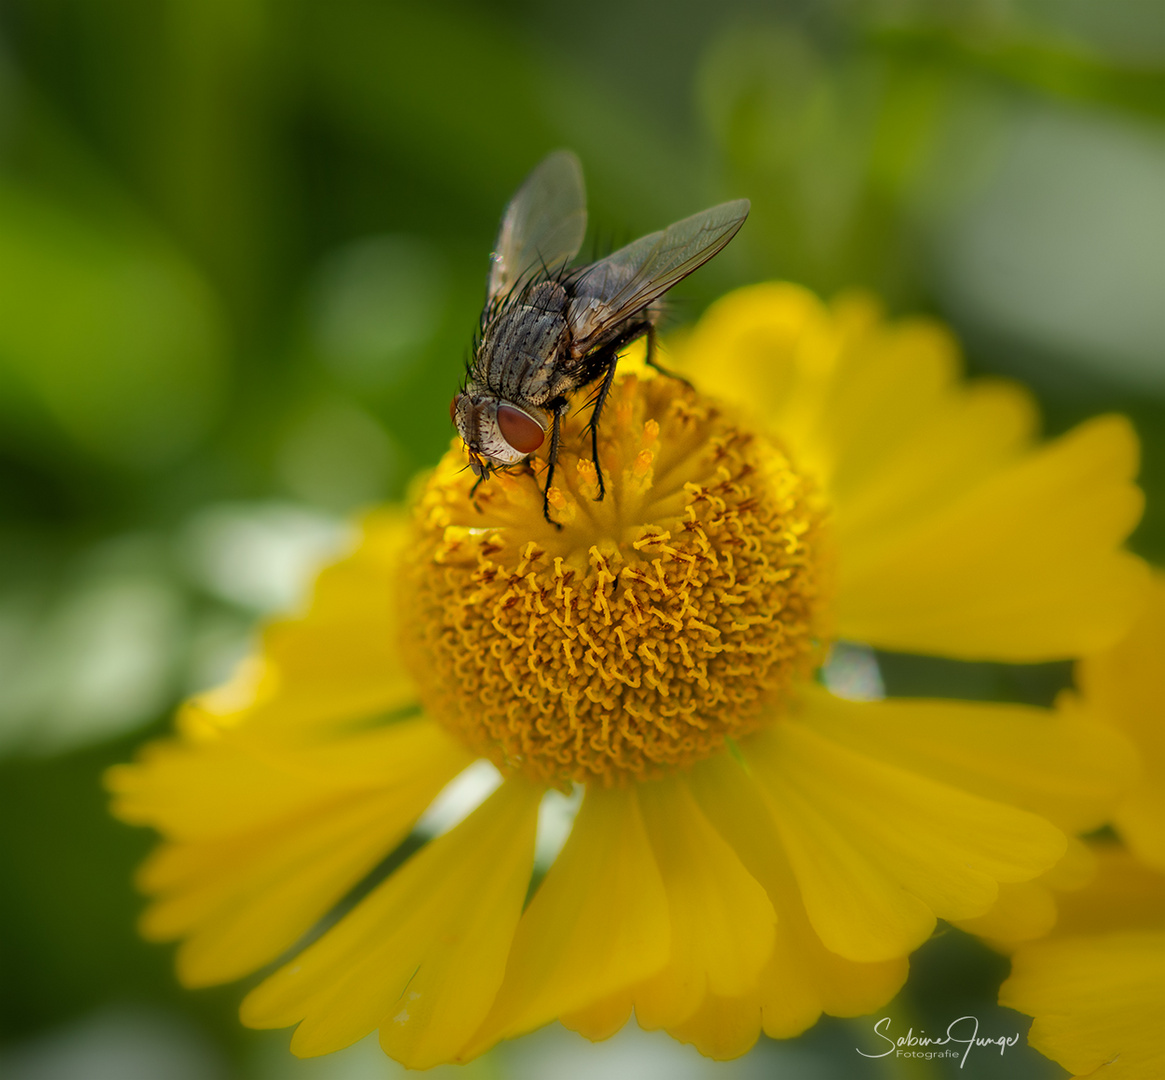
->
[488, 150, 586, 301]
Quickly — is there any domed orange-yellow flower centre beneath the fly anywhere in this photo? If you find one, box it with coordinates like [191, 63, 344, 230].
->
[402, 375, 828, 785]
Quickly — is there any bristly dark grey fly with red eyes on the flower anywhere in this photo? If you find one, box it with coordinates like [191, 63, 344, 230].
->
[450, 150, 749, 528]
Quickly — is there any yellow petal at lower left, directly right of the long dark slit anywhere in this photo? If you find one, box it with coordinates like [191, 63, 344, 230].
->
[241, 779, 542, 1068]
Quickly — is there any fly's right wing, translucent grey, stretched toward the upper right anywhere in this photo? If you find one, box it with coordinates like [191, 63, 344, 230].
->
[570, 199, 749, 355]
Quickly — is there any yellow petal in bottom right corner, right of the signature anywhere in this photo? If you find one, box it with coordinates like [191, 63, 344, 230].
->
[1000, 932, 1165, 1080]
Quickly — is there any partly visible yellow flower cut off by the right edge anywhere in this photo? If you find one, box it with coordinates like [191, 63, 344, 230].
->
[1000, 574, 1165, 1080]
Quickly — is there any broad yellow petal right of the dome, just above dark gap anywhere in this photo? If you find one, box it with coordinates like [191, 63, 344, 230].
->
[836, 417, 1145, 662]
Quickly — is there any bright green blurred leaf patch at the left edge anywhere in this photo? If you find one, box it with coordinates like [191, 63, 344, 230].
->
[0, 181, 226, 470]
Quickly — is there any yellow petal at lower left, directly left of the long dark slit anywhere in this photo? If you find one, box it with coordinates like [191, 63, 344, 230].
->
[121, 720, 469, 986]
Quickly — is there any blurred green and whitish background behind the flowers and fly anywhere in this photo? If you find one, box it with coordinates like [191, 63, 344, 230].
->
[0, 0, 1165, 1080]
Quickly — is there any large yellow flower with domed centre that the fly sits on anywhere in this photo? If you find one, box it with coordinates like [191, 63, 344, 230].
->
[108, 285, 1144, 1067]
